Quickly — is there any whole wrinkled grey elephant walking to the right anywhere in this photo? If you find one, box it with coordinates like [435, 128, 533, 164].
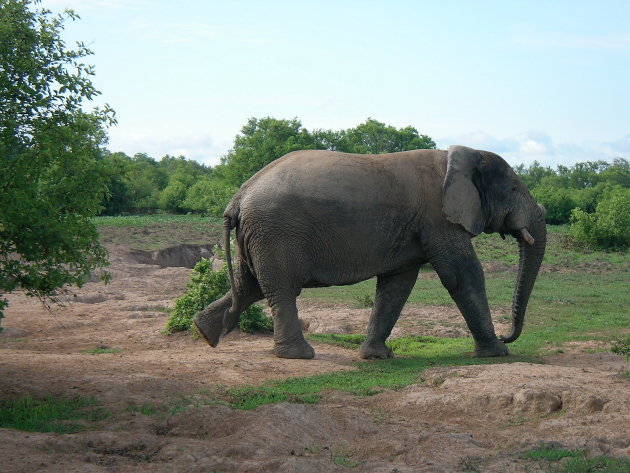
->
[194, 146, 546, 358]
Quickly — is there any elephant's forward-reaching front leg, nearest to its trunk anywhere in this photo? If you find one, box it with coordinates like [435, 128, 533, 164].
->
[431, 242, 508, 356]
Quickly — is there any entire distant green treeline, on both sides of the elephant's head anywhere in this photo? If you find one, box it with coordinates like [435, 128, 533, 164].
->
[101, 117, 630, 225]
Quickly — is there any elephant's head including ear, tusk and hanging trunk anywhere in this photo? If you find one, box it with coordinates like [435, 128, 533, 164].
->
[442, 146, 547, 343]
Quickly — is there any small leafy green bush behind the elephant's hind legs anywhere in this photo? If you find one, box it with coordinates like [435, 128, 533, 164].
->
[165, 258, 273, 334]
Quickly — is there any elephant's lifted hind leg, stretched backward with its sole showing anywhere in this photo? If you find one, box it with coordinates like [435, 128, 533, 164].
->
[193, 262, 263, 347]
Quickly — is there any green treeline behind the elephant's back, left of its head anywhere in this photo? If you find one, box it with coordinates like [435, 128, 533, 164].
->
[101, 117, 435, 216]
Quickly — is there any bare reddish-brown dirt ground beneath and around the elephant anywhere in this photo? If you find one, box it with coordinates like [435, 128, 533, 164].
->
[0, 242, 630, 473]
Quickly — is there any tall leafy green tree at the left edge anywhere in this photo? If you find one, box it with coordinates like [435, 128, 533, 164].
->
[0, 0, 115, 322]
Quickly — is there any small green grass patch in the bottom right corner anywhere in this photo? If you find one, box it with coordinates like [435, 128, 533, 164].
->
[522, 447, 630, 473]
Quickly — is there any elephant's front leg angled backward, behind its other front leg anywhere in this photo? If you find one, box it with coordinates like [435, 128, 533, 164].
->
[359, 268, 419, 358]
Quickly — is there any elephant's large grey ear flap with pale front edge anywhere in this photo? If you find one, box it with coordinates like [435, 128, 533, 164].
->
[442, 146, 485, 235]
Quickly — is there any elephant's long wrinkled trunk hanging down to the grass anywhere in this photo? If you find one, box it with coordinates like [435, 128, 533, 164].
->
[501, 220, 547, 343]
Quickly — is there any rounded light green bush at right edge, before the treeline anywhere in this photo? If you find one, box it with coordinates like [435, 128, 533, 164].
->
[571, 189, 630, 250]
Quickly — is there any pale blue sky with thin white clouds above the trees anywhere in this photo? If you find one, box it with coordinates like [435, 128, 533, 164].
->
[39, 0, 630, 166]
